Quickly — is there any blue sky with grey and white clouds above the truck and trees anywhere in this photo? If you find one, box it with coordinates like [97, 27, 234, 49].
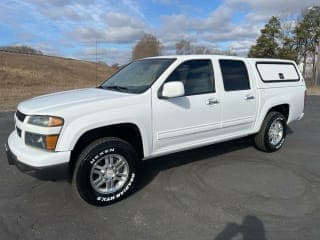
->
[0, 0, 319, 64]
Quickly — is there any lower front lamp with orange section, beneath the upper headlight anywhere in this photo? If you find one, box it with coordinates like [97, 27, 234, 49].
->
[25, 132, 59, 151]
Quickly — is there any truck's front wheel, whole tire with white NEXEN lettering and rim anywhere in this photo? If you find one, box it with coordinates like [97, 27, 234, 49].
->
[72, 138, 138, 206]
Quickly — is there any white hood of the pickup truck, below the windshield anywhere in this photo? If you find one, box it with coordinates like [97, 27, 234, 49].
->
[18, 88, 132, 114]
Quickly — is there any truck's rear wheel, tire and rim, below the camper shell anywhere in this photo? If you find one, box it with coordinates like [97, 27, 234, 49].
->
[254, 112, 287, 152]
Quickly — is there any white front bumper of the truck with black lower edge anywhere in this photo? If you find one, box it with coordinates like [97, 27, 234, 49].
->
[5, 131, 71, 169]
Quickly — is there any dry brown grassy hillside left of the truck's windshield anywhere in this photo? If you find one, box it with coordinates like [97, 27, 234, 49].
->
[0, 52, 115, 111]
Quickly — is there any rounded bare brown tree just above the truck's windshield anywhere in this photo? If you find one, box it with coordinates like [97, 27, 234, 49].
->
[132, 34, 161, 60]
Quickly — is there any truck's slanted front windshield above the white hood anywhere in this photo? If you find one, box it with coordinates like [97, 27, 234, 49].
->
[100, 58, 175, 93]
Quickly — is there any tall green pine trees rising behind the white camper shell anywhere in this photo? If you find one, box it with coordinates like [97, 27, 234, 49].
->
[248, 6, 320, 85]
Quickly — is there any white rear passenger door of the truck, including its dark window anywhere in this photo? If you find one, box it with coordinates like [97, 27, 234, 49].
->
[218, 59, 257, 134]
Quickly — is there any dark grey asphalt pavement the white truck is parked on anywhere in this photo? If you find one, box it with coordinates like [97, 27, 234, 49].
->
[0, 97, 320, 240]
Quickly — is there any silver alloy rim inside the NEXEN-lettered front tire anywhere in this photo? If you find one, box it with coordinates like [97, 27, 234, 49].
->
[90, 154, 129, 194]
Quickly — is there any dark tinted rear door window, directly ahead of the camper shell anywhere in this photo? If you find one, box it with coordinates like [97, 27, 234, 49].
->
[219, 60, 250, 91]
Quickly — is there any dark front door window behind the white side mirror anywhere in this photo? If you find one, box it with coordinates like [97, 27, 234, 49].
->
[166, 60, 215, 96]
